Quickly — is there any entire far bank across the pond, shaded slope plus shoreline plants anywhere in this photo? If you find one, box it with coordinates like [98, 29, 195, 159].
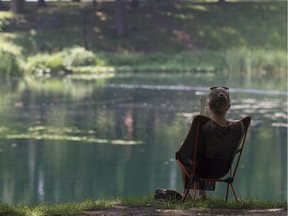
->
[0, 1, 287, 76]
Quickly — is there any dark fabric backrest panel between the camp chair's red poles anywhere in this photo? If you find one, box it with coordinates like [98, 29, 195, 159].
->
[196, 119, 244, 178]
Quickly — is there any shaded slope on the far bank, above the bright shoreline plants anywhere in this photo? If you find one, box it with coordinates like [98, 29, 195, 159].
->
[0, 1, 287, 55]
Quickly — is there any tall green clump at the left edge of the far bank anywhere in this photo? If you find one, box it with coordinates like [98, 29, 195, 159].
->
[0, 49, 22, 78]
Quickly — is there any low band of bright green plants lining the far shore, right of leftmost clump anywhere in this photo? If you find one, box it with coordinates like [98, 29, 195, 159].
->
[28, 47, 287, 76]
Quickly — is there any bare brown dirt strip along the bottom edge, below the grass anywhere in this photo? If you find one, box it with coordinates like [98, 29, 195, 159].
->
[80, 206, 287, 216]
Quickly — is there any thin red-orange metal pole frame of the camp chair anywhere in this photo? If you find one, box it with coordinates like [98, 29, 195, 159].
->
[177, 116, 251, 202]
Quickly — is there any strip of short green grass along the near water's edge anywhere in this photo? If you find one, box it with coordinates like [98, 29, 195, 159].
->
[0, 197, 287, 216]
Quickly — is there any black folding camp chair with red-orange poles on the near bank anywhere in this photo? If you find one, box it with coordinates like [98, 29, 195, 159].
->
[175, 115, 251, 202]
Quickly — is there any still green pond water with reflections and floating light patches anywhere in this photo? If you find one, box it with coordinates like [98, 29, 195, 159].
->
[0, 73, 287, 203]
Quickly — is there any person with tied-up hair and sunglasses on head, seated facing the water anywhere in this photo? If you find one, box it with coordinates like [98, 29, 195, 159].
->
[176, 87, 232, 200]
